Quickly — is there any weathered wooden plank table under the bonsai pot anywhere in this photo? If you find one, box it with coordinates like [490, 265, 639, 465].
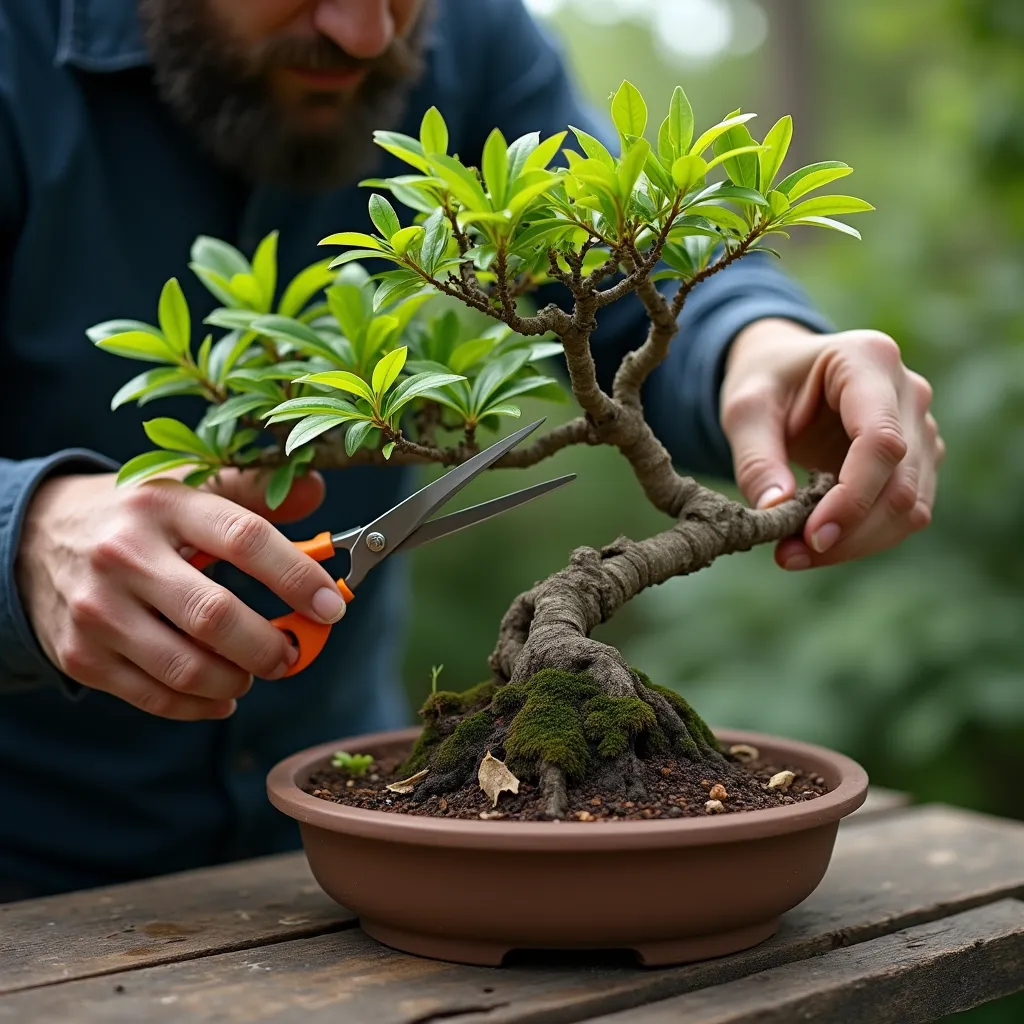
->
[0, 793, 1024, 1024]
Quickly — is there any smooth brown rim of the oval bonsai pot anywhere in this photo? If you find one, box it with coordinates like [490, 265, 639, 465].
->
[266, 727, 867, 852]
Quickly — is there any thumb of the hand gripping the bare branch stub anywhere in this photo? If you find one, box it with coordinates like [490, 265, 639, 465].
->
[722, 386, 797, 508]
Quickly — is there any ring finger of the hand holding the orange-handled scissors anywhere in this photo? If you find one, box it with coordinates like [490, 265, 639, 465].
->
[114, 611, 253, 702]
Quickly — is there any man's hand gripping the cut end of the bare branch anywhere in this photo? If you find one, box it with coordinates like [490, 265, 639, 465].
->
[721, 319, 945, 569]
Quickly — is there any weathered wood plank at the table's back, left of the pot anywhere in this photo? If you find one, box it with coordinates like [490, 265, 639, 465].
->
[0, 853, 354, 992]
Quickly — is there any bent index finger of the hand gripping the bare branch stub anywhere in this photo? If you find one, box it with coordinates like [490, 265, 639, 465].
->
[804, 362, 907, 554]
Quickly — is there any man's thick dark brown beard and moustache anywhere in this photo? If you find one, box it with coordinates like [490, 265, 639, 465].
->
[139, 0, 429, 190]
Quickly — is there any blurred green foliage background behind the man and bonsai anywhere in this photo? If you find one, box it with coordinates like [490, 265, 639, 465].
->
[395, 0, 1024, 1024]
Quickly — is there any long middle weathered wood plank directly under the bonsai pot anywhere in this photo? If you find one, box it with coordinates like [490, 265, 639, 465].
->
[0, 806, 1024, 1024]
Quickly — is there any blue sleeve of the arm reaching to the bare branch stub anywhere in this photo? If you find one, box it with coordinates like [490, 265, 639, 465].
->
[467, 0, 835, 479]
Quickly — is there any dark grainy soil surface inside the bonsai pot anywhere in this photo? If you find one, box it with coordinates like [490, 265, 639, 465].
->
[302, 752, 828, 821]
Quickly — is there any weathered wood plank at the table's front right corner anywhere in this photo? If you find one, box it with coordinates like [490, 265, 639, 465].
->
[591, 900, 1024, 1024]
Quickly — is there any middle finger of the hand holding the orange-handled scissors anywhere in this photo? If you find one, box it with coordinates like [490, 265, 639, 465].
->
[134, 549, 303, 680]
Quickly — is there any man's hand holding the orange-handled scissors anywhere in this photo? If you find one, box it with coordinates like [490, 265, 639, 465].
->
[15, 471, 345, 721]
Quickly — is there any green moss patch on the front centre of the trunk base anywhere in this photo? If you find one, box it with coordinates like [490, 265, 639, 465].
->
[505, 669, 599, 779]
